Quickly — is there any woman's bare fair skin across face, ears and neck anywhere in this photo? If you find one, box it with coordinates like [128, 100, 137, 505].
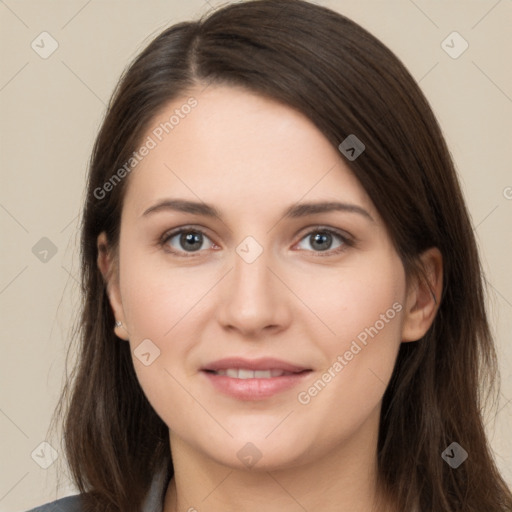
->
[98, 86, 442, 512]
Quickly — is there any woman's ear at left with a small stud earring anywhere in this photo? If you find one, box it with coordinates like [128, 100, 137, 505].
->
[97, 231, 128, 341]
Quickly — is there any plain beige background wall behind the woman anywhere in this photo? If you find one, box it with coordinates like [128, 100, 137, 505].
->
[0, 0, 512, 512]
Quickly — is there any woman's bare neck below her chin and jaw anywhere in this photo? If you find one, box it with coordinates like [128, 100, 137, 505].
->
[164, 411, 392, 512]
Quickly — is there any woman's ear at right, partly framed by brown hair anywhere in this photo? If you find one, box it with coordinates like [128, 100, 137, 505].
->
[402, 247, 443, 342]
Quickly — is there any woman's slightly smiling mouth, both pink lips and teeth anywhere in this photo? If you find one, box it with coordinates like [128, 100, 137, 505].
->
[201, 358, 313, 400]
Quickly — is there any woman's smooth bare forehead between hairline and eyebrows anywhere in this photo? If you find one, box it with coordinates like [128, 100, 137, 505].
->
[120, 86, 375, 220]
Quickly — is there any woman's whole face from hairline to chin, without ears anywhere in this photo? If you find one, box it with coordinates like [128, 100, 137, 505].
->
[99, 86, 424, 469]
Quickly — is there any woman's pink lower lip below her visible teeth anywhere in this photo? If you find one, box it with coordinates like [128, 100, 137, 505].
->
[202, 371, 311, 400]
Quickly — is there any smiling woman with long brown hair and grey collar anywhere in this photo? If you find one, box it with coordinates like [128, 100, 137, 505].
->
[27, 0, 512, 512]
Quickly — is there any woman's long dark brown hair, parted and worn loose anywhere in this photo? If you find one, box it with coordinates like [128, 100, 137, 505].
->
[50, 0, 512, 512]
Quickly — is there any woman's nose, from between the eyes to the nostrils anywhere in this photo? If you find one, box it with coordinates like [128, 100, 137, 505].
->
[216, 245, 292, 339]
